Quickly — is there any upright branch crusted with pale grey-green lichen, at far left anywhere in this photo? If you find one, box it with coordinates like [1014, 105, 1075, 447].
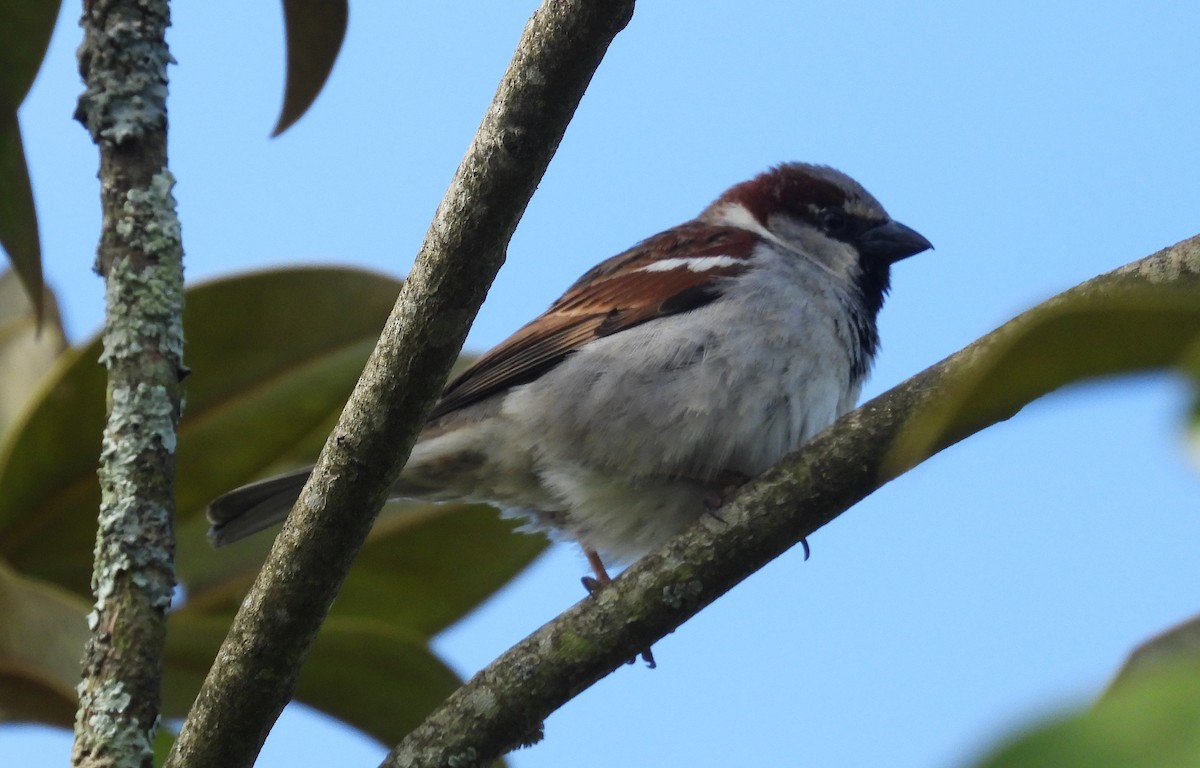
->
[72, 0, 184, 768]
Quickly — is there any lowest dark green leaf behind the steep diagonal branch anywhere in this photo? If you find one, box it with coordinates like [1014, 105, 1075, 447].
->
[163, 612, 458, 744]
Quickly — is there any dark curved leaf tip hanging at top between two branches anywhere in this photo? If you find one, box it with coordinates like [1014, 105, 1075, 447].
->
[271, 0, 349, 136]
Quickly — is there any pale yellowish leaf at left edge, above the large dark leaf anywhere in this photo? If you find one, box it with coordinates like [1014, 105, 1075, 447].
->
[0, 272, 67, 434]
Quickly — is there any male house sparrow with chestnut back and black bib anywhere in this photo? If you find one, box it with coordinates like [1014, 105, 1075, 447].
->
[208, 163, 932, 582]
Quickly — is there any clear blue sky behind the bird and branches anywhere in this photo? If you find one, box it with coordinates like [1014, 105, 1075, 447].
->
[0, 0, 1200, 768]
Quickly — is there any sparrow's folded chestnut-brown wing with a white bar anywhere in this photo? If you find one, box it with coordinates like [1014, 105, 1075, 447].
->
[430, 222, 757, 420]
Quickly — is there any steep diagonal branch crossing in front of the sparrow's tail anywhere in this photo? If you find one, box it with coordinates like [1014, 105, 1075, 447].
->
[168, 0, 634, 768]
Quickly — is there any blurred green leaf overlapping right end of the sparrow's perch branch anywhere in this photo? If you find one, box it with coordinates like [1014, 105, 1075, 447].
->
[884, 286, 1200, 475]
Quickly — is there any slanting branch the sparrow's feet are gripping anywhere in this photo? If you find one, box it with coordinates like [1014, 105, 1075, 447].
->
[383, 236, 1200, 768]
